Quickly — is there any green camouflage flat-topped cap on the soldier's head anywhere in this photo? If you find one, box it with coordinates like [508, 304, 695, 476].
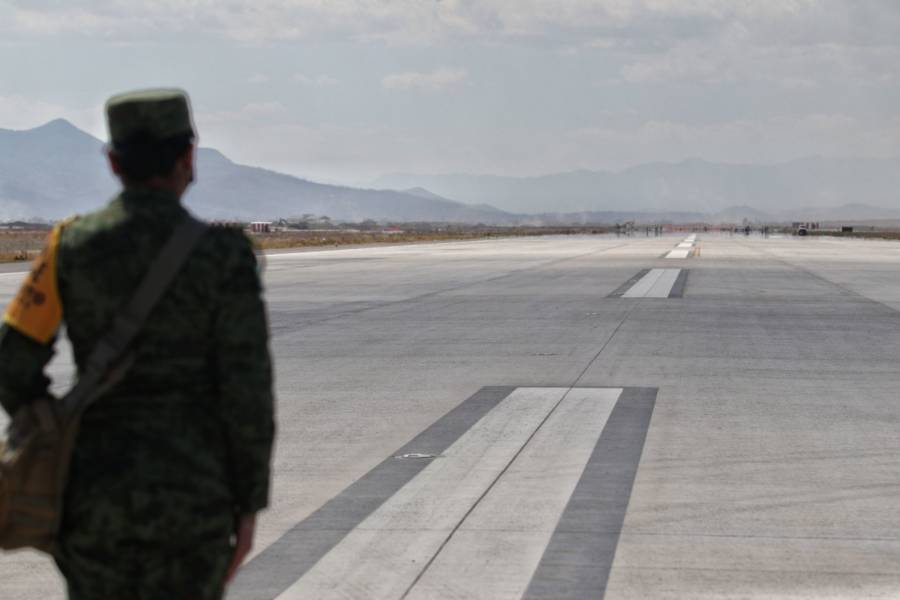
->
[106, 88, 194, 145]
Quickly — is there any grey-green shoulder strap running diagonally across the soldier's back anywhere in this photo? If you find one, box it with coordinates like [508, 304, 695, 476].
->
[61, 216, 207, 416]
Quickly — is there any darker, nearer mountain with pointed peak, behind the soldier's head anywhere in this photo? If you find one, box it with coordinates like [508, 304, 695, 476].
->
[0, 119, 509, 223]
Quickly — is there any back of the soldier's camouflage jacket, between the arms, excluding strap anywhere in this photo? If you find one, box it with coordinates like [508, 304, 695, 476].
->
[57, 189, 267, 596]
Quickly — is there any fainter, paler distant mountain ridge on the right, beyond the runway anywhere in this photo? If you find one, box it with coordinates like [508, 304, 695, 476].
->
[375, 158, 900, 215]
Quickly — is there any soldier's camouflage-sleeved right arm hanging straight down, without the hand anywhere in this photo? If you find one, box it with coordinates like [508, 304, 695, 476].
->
[215, 232, 275, 514]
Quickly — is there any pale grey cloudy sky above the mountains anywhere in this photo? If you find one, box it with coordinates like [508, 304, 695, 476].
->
[0, 0, 900, 185]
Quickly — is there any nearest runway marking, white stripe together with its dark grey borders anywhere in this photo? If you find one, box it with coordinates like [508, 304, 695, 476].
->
[228, 388, 655, 600]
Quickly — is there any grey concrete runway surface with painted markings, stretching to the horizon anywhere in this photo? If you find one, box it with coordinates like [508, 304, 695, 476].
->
[0, 234, 900, 600]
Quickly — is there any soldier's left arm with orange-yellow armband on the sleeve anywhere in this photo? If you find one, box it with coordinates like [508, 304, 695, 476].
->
[0, 225, 62, 415]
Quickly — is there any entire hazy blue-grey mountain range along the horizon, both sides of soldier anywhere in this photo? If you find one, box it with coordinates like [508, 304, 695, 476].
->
[0, 119, 900, 225]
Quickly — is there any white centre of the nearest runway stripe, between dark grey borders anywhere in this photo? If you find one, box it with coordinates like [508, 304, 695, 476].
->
[278, 388, 621, 600]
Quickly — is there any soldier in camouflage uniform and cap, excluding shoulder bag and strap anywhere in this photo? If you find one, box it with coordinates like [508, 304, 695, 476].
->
[0, 90, 274, 600]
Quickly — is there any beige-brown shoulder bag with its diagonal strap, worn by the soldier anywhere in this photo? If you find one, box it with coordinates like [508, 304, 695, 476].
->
[0, 217, 206, 554]
